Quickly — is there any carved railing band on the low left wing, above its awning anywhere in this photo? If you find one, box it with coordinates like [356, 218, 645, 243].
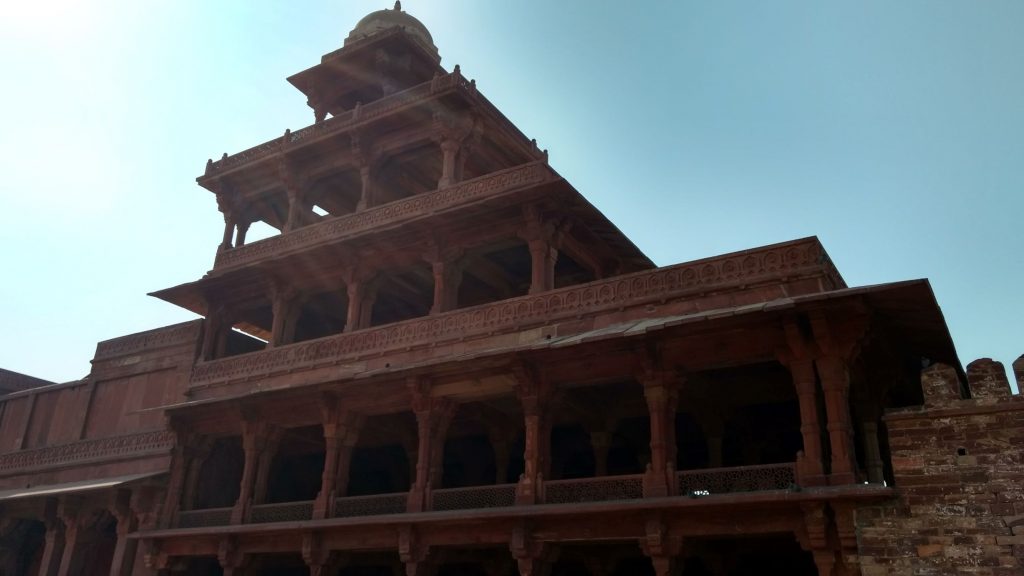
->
[0, 430, 174, 474]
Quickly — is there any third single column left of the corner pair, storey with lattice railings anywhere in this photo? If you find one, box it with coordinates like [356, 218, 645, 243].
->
[409, 377, 457, 511]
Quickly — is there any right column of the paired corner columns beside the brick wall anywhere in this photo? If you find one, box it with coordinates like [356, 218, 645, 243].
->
[815, 356, 856, 485]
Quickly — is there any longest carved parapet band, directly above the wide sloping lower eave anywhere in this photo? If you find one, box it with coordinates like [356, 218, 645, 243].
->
[191, 239, 835, 386]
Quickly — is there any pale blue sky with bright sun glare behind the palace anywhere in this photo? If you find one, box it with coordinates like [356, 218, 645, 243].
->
[0, 0, 1024, 389]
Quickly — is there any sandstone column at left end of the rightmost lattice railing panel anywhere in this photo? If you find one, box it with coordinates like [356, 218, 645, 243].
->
[640, 369, 678, 496]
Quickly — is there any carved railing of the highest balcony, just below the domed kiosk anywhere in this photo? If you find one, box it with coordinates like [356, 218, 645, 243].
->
[204, 72, 466, 177]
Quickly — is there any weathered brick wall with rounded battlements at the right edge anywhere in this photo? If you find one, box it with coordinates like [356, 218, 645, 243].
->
[857, 356, 1024, 576]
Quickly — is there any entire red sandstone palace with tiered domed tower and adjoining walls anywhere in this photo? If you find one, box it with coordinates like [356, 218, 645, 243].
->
[0, 5, 1024, 576]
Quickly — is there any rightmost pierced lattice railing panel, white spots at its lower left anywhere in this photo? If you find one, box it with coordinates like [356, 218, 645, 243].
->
[677, 462, 797, 496]
